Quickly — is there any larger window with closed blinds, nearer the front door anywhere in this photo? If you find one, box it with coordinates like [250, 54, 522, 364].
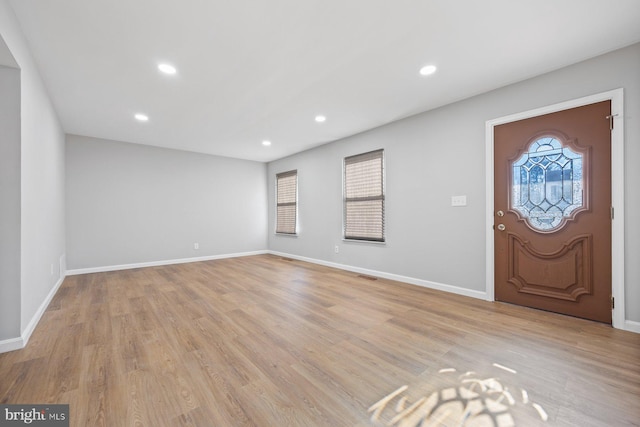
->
[344, 150, 384, 242]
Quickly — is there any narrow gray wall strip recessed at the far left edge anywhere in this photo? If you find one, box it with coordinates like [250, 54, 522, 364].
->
[0, 66, 20, 341]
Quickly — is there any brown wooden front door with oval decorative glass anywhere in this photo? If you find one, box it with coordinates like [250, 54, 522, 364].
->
[494, 101, 611, 323]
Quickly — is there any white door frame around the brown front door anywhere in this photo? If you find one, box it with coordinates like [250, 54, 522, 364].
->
[485, 88, 625, 329]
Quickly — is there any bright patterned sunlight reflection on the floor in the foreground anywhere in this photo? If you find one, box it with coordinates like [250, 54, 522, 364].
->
[369, 363, 548, 427]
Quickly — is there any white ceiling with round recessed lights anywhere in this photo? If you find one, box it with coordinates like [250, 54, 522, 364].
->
[10, 0, 640, 162]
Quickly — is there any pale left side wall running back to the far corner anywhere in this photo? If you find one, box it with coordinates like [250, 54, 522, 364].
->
[0, 0, 65, 339]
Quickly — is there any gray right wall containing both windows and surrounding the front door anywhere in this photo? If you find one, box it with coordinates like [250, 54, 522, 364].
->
[268, 44, 640, 321]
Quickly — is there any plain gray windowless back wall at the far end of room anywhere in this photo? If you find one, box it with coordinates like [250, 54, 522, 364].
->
[66, 135, 267, 270]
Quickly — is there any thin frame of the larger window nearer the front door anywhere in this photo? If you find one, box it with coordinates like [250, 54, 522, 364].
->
[342, 148, 387, 244]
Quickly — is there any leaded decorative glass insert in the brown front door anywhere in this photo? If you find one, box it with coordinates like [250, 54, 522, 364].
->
[511, 136, 585, 233]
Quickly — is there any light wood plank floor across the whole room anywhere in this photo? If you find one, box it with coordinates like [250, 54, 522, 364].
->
[0, 255, 640, 427]
